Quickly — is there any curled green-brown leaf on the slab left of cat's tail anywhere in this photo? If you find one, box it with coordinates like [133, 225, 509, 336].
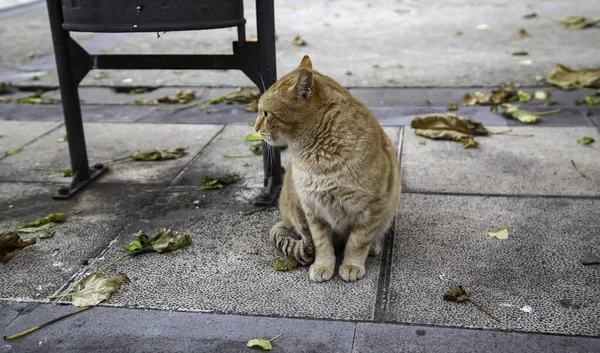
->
[124, 229, 192, 256]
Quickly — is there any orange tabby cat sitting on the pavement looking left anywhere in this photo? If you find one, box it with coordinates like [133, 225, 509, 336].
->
[255, 56, 400, 282]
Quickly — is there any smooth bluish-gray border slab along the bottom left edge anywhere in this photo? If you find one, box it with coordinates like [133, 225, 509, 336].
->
[0, 305, 356, 353]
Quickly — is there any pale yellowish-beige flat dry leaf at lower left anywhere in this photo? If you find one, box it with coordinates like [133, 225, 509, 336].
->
[72, 273, 128, 306]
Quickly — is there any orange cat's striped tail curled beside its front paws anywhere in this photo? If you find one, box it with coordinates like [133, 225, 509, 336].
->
[270, 222, 315, 266]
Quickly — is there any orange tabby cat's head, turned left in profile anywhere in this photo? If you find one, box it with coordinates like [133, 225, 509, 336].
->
[254, 55, 319, 147]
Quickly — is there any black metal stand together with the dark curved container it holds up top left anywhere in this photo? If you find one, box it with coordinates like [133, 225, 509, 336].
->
[46, 0, 283, 205]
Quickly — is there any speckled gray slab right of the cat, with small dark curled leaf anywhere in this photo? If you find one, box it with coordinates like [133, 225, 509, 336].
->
[386, 193, 600, 336]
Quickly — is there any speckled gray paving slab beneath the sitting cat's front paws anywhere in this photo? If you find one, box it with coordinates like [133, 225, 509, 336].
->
[70, 192, 379, 320]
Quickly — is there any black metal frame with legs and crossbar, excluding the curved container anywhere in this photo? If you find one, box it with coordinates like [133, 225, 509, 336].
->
[46, 0, 283, 205]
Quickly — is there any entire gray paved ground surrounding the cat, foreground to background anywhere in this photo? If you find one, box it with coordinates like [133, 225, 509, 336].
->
[0, 0, 600, 352]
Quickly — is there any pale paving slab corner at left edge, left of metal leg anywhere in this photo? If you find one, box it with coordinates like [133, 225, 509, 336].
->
[0, 120, 60, 155]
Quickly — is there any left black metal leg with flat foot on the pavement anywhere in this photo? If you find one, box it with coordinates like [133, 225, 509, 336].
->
[47, 0, 108, 199]
